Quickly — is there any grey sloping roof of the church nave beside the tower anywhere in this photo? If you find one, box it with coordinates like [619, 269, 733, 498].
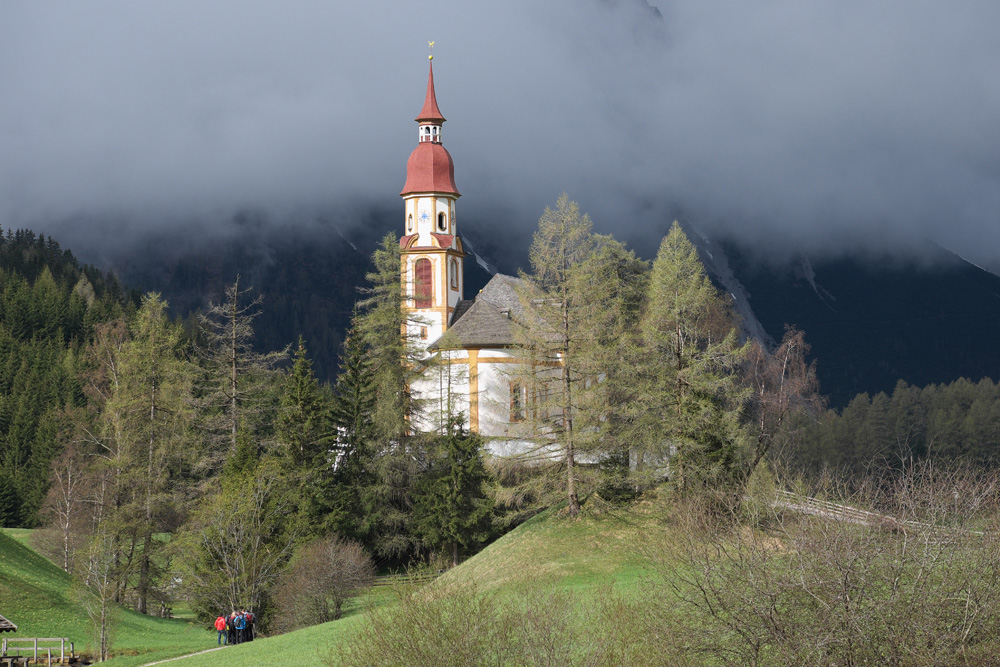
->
[431, 273, 522, 348]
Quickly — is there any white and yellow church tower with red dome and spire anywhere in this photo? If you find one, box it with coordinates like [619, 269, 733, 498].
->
[399, 56, 465, 347]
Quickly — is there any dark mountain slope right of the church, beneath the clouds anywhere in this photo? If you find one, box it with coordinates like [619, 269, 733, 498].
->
[714, 237, 1000, 407]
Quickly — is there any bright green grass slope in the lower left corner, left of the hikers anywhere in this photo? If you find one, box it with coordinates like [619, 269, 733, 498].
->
[0, 531, 215, 665]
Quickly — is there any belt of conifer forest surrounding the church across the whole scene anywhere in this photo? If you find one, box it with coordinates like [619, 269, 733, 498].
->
[0, 195, 1000, 656]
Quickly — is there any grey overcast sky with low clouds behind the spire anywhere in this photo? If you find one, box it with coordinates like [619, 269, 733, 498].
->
[0, 0, 1000, 262]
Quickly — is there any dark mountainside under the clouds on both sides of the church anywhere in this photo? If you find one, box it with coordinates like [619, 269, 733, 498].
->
[60, 211, 1000, 407]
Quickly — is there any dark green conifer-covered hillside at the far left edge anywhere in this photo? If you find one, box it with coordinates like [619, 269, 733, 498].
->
[0, 229, 138, 527]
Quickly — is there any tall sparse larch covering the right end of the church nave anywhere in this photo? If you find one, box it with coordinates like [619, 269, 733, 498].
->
[512, 194, 642, 516]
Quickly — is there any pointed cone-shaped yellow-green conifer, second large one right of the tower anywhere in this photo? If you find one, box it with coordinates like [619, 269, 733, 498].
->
[634, 222, 748, 488]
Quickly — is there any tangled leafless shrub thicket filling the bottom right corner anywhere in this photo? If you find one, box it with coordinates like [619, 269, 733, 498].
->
[652, 466, 1000, 666]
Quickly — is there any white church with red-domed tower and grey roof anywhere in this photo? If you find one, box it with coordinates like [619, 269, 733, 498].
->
[399, 60, 527, 455]
